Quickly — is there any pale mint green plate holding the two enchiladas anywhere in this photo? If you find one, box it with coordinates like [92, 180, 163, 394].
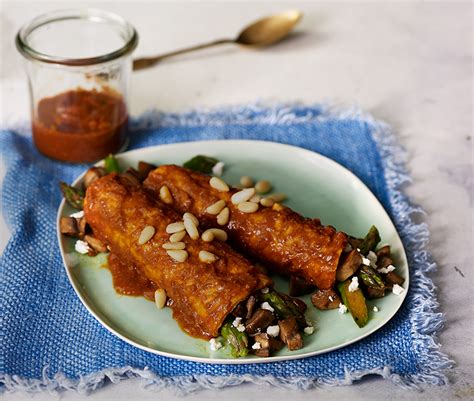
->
[58, 141, 409, 364]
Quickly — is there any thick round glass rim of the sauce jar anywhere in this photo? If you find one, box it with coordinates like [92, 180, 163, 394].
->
[15, 8, 138, 66]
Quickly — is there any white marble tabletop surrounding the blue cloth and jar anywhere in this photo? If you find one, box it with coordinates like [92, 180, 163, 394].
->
[0, 1, 474, 401]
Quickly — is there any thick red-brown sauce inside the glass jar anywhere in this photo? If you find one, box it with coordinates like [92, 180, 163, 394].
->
[33, 88, 128, 162]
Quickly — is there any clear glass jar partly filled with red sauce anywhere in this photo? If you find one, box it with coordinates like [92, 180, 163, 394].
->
[16, 9, 138, 163]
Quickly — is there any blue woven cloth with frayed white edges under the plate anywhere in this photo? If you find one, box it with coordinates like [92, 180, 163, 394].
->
[0, 107, 449, 390]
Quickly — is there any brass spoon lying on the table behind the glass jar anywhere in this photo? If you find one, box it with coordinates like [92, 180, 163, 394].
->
[133, 10, 303, 70]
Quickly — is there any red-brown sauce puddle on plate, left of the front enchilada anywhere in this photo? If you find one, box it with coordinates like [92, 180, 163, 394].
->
[107, 253, 158, 301]
